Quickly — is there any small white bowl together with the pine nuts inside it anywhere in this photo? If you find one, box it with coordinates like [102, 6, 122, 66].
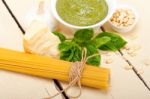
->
[108, 5, 139, 33]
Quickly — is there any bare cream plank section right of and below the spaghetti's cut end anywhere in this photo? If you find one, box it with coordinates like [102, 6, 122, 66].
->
[63, 53, 150, 99]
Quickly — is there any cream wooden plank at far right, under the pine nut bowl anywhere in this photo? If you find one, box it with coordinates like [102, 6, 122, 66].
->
[105, 0, 150, 90]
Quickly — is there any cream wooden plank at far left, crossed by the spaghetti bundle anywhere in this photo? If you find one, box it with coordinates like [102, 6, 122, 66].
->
[0, 1, 61, 99]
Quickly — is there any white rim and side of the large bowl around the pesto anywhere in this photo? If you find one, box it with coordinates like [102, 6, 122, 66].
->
[51, 0, 116, 30]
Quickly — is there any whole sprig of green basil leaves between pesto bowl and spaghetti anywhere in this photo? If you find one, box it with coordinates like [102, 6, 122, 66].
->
[58, 29, 127, 66]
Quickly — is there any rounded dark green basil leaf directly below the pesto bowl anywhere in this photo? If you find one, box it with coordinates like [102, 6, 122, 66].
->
[73, 29, 94, 44]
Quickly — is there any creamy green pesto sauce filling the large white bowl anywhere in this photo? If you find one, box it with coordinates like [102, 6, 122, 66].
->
[56, 0, 108, 26]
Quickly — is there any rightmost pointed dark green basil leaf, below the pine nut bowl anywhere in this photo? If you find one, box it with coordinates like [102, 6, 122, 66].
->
[96, 32, 127, 51]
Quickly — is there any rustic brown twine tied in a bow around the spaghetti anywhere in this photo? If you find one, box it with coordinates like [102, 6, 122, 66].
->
[44, 48, 99, 99]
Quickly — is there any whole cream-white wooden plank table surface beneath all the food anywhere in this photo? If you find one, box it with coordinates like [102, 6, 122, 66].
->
[0, 0, 150, 99]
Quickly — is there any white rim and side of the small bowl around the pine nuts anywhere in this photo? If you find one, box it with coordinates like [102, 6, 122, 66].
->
[108, 4, 139, 33]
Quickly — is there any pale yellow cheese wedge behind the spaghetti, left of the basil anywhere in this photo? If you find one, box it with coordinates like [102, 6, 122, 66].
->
[23, 21, 60, 58]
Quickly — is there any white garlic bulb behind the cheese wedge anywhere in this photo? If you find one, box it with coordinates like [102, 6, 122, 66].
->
[23, 0, 58, 31]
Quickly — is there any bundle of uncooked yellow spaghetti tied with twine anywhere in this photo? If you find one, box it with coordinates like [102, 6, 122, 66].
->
[0, 48, 110, 90]
